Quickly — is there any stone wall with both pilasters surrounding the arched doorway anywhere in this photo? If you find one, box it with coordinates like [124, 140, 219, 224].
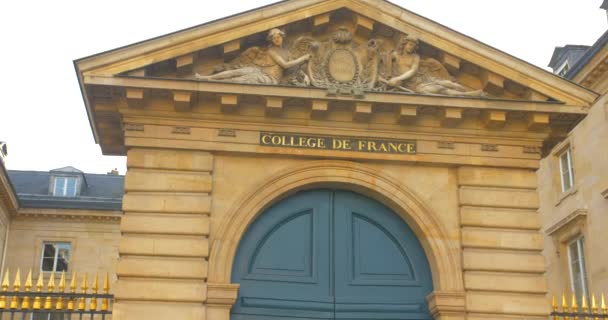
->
[114, 148, 549, 320]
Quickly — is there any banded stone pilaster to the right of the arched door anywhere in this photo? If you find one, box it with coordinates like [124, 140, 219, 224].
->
[458, 167, 549, 320]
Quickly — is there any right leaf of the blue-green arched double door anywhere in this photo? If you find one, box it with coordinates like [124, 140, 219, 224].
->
[334, 191, 432, 319]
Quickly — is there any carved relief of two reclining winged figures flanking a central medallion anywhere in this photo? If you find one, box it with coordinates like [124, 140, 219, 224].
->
[195, 27, 485, 96]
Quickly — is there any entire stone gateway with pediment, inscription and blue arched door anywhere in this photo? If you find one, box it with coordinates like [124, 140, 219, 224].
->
[75, 0, 598, 320]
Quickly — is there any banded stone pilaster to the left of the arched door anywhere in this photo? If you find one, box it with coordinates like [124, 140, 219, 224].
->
[114, 148, 213, 320]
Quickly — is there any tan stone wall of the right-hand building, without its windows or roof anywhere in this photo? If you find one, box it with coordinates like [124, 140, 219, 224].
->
[538, 91, 608, 294]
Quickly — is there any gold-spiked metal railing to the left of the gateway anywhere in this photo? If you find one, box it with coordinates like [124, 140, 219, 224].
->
[0, 270, 114, 320]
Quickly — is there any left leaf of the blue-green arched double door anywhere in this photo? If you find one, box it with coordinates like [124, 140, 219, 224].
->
[232, 191, 334, 320]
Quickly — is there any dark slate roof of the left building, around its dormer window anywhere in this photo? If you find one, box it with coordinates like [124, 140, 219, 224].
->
[8, 170, 124, 211]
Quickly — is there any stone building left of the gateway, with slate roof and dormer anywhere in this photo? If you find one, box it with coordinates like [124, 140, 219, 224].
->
[1, 167, 124, 292]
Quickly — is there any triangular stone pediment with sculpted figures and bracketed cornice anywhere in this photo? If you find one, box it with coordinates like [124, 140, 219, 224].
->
[75, 0, 598, 154]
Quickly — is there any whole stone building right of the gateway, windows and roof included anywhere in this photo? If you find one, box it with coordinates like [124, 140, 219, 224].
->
[538, 27, 608, 297]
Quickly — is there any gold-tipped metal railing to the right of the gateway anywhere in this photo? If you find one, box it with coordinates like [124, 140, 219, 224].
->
[551, 293, 608, 320]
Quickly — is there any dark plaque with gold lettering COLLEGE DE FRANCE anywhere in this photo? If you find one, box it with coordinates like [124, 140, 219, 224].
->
[260, 132, 416, 154]
